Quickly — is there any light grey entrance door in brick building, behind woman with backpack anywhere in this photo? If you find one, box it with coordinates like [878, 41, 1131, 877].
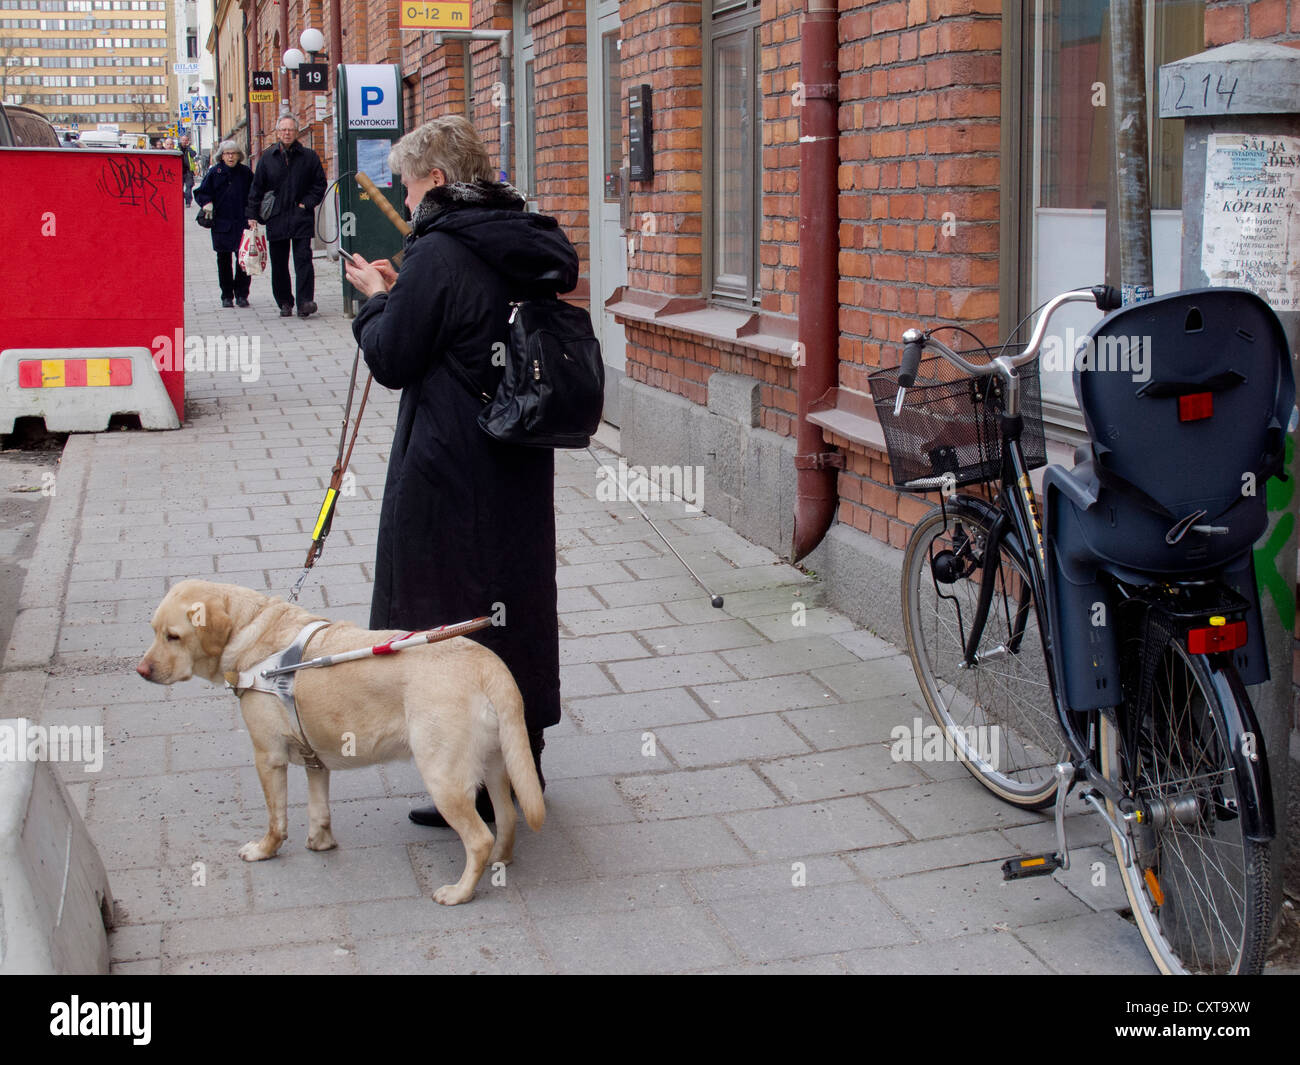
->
[586, 0, 628, 425]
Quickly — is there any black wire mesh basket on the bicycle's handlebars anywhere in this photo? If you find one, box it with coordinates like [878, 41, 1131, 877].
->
[868, 347, 1048, 492]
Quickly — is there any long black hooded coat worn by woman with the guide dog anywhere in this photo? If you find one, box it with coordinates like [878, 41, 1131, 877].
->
[352, 182, 579, 732]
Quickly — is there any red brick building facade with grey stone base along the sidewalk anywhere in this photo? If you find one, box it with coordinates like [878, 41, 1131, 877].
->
[215, 0, 1300, 696]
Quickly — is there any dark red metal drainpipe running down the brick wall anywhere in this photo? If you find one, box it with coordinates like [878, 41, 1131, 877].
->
[790, 0, 844, 562]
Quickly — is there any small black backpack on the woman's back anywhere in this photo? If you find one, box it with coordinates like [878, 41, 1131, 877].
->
[458, 296, 605, 447]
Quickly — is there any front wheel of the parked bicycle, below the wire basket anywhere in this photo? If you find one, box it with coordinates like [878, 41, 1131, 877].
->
[902, 501, 1066, 810]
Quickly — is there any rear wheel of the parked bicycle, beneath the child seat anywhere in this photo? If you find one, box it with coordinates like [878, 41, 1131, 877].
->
[1101, 638, 1269, 974]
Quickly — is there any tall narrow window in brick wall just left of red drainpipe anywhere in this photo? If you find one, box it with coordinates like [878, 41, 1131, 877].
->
[705, 0, 763, 306]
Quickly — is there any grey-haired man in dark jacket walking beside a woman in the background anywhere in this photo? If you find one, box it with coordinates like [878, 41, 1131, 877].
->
[244, 114, 325, 319]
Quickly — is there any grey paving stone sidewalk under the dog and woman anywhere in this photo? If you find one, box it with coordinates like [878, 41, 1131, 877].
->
[0, 225, 1153, 974]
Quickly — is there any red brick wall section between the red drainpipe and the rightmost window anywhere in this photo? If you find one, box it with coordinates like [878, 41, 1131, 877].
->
[835, 0, 1002, 546]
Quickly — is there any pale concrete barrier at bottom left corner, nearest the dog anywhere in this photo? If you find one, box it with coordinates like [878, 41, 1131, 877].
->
[0, 718, 113, 975]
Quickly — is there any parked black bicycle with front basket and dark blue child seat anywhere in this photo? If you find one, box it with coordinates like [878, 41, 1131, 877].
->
[871, 286, 1296, 973]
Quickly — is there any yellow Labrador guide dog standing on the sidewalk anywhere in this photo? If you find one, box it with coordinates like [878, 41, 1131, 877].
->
[137, 580, 546, 906]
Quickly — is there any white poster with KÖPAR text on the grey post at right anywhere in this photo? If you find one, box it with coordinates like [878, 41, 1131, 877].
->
[1201, 133, 1300, 312]
